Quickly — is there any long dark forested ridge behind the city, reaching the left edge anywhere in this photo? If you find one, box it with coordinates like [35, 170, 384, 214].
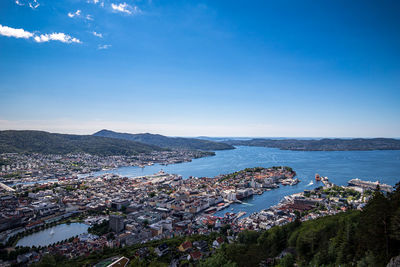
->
[0, 131, 165, 156]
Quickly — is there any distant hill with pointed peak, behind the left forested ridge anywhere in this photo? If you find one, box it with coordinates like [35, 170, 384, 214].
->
[93, 130, 234, 150]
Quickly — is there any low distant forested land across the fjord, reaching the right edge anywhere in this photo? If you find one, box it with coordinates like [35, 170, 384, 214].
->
[224, 138, 400, 151]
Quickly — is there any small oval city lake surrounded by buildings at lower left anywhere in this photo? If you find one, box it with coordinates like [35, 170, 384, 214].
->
[17, 223, 89, 247]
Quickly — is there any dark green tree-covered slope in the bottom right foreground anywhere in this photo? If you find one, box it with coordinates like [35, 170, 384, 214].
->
[200, 183, 400, 267]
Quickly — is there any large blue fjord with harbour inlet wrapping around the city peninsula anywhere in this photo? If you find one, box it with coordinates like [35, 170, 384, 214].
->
[90, 146, 400, 218]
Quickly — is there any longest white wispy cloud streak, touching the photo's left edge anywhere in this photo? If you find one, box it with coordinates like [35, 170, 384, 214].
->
[0, 24, 82, 44]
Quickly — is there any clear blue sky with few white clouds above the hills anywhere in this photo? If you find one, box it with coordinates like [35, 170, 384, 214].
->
[0, 0, 400, 137]
